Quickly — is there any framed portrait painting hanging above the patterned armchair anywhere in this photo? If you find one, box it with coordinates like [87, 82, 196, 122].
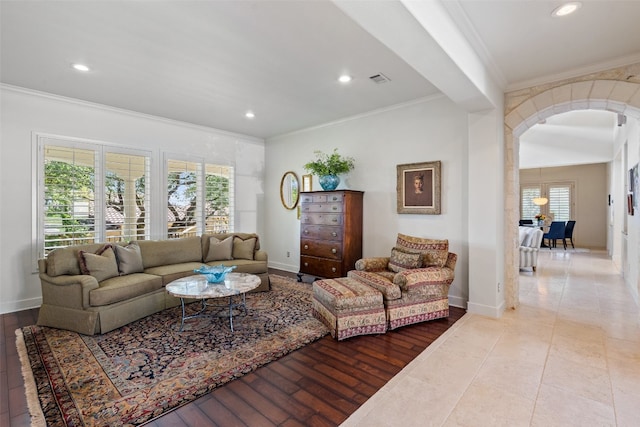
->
[396, 161, 440, 215]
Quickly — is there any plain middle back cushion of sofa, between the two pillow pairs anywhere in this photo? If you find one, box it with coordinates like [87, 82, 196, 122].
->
[137, 237, 202, 269]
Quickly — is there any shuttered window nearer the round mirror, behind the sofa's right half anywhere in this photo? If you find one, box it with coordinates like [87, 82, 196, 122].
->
[166, 159, 234, 238]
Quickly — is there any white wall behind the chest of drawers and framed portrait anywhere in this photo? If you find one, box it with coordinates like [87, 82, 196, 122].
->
[265, 97, 470, 307]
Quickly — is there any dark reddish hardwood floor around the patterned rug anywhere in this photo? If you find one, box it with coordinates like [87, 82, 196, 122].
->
[0, 270, 465, 427]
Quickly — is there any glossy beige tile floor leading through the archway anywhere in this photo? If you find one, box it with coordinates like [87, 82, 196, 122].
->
[342, 249, 640, 427]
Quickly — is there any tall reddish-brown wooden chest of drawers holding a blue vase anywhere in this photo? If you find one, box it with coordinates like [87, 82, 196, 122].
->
[298, 190, 364, 280]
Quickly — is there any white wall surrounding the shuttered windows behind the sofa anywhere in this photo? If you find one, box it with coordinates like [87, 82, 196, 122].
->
[0, 86, 264, 313]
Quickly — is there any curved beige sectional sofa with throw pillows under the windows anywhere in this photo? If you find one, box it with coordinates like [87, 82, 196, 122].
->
[38, 233, 271, 335]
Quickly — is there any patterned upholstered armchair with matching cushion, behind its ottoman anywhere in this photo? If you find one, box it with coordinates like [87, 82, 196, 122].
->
[348, 234, 458, 329]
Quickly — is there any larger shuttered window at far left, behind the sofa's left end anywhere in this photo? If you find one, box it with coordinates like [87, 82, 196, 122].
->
[34, 135, 151, 258]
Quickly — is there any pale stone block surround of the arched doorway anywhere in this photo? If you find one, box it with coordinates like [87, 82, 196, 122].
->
[504, 72, 640, 308]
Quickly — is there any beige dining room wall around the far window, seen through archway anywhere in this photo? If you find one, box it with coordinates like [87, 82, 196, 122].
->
[520, 163, 609, 249]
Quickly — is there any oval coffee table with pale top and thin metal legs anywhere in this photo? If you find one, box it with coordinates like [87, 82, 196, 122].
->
[166, 273, 260, 332]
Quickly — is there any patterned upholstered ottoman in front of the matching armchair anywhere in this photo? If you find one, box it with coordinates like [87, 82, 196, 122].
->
[312, 277, 387, 341]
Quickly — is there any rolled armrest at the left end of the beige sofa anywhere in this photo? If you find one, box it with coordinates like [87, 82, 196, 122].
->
[40, 273, 99, 309]
